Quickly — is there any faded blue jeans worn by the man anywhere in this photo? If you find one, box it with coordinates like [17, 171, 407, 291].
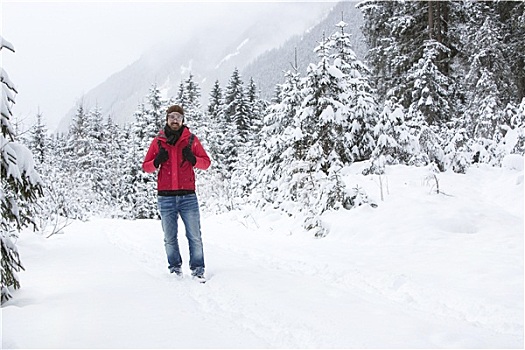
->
[157, 194, 204, 275]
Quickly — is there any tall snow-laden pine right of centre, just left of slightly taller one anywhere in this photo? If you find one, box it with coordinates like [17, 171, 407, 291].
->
[281, 30, 362, 236]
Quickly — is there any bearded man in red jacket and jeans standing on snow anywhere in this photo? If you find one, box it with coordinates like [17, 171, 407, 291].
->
[142, 105, 210, 283]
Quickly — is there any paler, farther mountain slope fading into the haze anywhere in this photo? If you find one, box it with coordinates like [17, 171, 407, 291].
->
[59, 2, 336, 131]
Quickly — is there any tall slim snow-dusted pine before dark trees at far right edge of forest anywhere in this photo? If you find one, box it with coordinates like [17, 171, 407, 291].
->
[463, 3, 519, 165]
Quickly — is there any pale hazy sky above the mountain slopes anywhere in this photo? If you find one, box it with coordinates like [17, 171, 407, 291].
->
[0, 0, 333, 129]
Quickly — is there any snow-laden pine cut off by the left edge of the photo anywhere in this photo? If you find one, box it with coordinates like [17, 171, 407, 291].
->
[0, 36, 42, 304]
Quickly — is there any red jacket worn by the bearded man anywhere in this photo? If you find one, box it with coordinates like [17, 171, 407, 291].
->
[142, 127, 211, 191]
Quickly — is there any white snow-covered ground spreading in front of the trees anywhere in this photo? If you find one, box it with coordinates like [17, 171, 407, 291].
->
[2, 163, 524, 348]
